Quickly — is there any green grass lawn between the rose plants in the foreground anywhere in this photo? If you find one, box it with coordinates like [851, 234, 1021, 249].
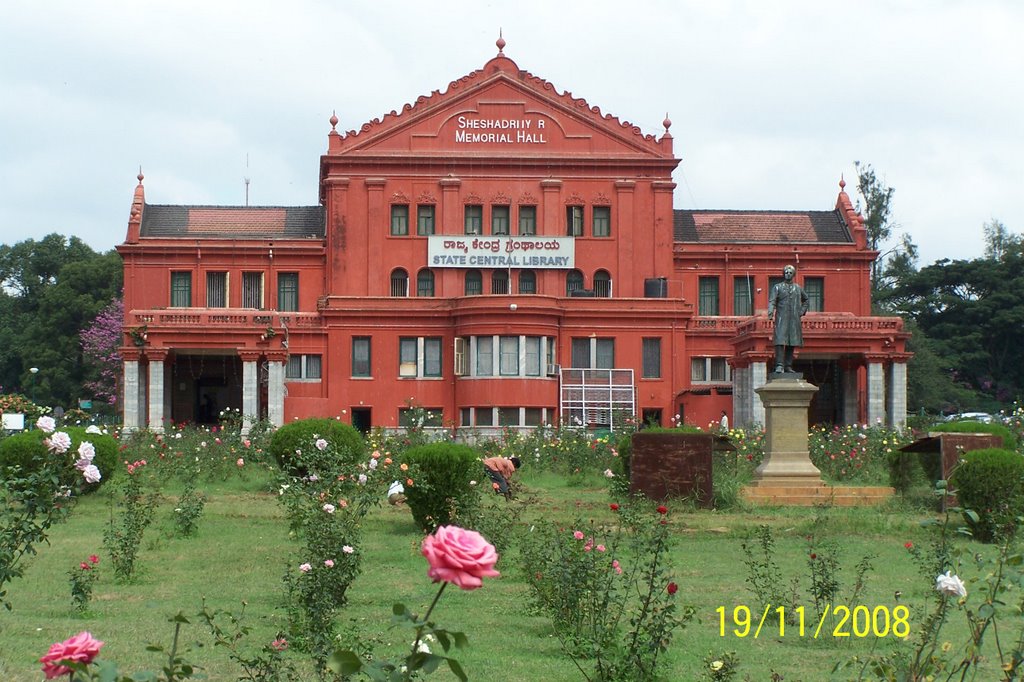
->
[0, 470, 1016, 682]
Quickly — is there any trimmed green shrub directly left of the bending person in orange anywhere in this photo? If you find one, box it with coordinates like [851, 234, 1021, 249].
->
[402, 442, 479, 532]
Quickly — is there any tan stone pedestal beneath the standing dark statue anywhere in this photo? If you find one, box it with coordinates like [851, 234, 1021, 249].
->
[751, 372, 824, 488]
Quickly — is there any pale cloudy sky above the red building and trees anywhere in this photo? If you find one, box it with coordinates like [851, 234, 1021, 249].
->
[0, 0, 1024, 265]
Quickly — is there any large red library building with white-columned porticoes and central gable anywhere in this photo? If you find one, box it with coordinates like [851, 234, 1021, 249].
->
[118, 41, 908, 432]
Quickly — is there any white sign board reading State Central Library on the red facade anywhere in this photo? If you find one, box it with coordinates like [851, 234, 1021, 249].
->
[427, 235, 575, 270]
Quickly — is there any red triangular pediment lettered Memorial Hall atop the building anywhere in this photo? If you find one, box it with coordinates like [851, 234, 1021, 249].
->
[330, 54, 672, 159]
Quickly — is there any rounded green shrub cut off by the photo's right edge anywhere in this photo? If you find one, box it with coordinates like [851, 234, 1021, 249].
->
[949, 447, 1024, 543]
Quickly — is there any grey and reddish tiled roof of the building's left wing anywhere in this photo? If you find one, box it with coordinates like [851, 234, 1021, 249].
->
[140, 204, 325, 239]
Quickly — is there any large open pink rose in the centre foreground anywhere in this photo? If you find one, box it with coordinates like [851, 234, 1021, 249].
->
[422, 525, 501, 590]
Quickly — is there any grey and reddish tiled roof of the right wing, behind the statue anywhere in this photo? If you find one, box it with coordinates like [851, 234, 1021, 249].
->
[673, 209, 853, 244]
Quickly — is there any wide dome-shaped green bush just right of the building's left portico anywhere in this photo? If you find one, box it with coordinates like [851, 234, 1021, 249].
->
[270, 418, 367, 476]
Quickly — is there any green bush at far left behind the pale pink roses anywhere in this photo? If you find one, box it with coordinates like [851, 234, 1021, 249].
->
[0, 426, 118, 495]
